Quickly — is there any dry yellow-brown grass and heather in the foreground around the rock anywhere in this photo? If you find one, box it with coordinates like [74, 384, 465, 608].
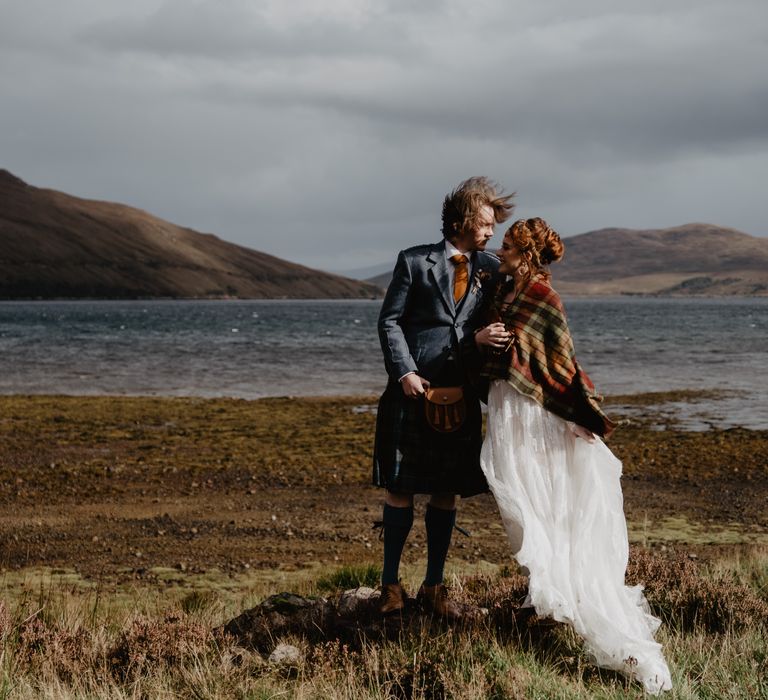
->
[0, 547, 768, 700]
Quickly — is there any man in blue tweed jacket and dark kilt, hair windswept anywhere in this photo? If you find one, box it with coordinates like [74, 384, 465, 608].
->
[373, 177, 513, 620]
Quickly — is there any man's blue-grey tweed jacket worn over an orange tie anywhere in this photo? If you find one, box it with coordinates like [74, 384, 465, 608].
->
[379, 241, 499, 382]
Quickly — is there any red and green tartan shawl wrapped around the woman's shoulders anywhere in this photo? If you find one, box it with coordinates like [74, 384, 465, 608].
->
[481, 277, 617, 437]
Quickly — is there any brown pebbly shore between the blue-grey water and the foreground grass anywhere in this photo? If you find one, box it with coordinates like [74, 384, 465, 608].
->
[0, 394, 768, 580]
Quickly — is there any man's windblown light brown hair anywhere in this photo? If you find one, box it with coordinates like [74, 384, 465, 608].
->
[443, 177, 515, 240]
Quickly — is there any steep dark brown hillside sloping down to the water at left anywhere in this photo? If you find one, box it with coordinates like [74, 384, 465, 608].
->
[0, 170, 381, 299]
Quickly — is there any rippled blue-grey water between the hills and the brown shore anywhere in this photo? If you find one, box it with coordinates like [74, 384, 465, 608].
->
[0, 296, 768, 430]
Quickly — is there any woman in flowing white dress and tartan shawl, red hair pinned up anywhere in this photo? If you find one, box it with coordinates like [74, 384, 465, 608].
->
[475, 218, 672, 695]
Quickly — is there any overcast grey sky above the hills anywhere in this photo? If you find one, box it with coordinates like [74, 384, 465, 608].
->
[0, 0, 768, 270]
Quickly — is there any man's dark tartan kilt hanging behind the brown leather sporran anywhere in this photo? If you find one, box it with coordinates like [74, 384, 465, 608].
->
[373, 383, 488, 497]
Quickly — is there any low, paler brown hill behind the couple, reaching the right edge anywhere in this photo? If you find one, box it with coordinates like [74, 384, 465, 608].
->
[366, 224, 768, 296]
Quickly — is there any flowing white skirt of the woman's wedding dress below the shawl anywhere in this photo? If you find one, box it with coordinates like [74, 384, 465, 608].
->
[481, 380, 672, 695]
